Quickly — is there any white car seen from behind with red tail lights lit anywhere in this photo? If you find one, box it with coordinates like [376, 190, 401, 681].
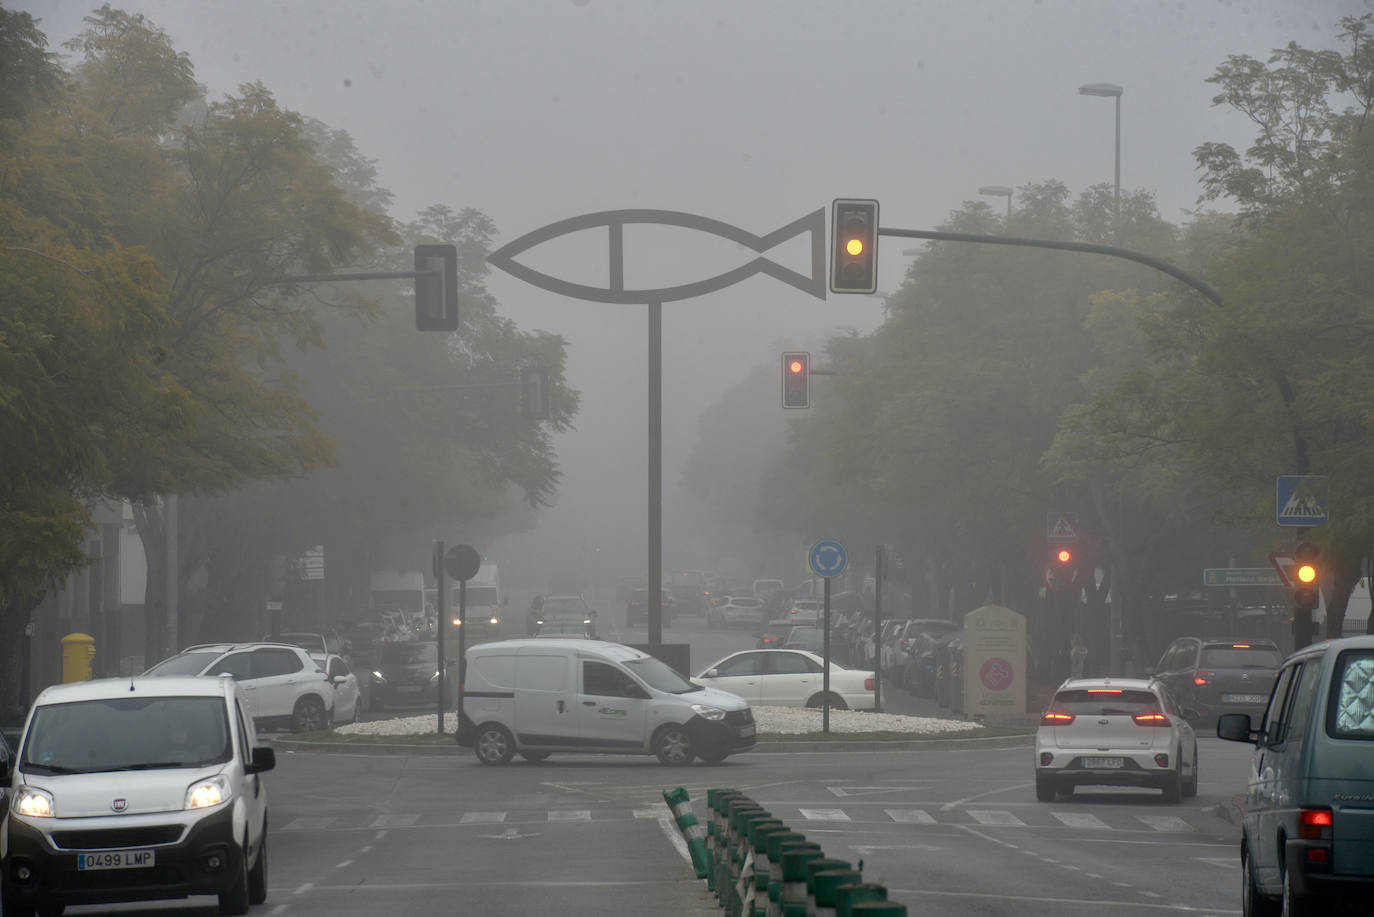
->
[1035, 678, 1198, 803]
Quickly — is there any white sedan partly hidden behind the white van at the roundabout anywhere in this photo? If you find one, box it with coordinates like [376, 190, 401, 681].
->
[692, 649, 874, 709]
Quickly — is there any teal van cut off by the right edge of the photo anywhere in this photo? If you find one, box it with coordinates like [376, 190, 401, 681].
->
[1216, 635, 1374, 917]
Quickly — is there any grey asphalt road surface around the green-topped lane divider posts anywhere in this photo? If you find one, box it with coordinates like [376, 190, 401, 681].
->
[59, 738, 1245, 917]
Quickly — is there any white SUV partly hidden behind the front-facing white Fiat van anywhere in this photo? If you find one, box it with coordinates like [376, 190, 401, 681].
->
[144, 643, 334, 733]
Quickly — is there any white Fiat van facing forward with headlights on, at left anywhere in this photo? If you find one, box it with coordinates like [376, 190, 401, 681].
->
[0, 678, 276, 917]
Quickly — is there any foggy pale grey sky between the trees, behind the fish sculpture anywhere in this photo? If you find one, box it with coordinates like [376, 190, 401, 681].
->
[21, 0, 1370, 580]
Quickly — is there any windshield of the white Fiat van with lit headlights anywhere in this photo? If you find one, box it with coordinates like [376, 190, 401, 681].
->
[23, 693, 234, 774]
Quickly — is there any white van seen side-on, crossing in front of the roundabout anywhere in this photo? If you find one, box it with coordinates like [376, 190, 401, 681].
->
[458, 639, 757, 764]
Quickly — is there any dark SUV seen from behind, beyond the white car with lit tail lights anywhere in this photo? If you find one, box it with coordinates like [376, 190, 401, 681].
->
[1146, 637, 1283, 725]
